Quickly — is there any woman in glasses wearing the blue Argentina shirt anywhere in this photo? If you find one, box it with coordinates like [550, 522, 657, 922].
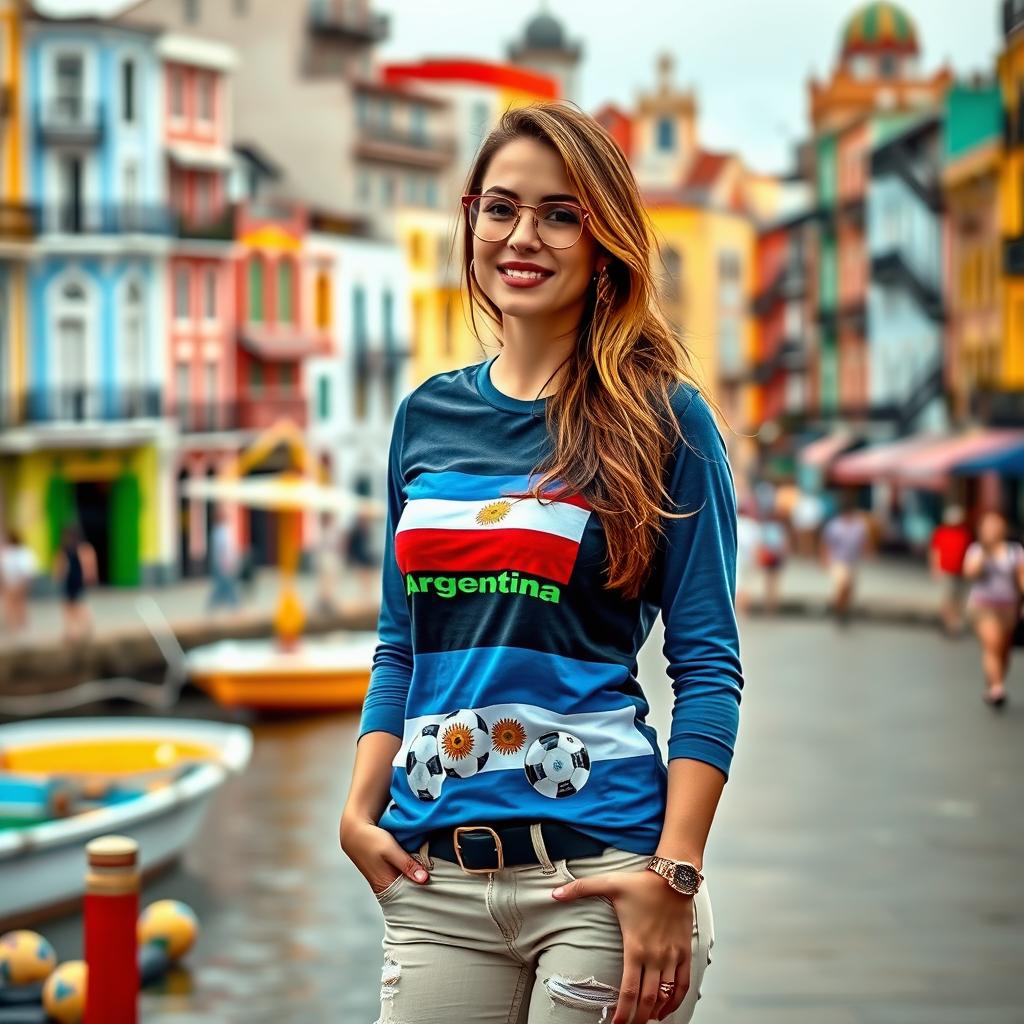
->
[340, 103, 742, 1024]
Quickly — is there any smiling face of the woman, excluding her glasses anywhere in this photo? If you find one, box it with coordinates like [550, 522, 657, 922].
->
[473, 138, 600, 321]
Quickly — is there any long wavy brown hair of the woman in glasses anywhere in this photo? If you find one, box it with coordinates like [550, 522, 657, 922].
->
[462, 101, 712, 598]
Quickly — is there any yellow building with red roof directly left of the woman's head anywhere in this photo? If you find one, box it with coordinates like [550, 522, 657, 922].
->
[384, 59, 558, 385]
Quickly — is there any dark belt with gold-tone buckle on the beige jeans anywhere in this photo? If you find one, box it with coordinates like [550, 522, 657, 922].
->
[426, 821, 607, 874]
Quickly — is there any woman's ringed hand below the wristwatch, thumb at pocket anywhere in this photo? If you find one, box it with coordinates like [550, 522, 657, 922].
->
[552, 869, 693, 1024]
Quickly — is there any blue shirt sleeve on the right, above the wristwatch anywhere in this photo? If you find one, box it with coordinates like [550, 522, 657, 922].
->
[660, 393, 743, 778]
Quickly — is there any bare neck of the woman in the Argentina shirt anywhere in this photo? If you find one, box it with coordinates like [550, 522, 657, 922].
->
[490, 299, 582, 401]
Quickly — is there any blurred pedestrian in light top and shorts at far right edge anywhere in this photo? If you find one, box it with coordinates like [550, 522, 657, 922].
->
[964, 512, 1024, 708]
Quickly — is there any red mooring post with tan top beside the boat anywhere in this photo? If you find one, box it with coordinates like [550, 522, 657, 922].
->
[83, 836, 139, 1024]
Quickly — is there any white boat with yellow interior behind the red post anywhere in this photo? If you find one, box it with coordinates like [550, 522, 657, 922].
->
[0, 718, 252, 933]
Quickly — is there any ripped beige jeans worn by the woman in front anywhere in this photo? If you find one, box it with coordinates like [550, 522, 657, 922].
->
[377, 830, 715, 1024]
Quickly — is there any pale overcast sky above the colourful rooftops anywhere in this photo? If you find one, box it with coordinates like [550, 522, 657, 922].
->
[373, 0, 1001, 173]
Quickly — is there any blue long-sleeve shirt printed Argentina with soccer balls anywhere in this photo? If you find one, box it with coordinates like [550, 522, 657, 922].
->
[359, 359, 743, 853]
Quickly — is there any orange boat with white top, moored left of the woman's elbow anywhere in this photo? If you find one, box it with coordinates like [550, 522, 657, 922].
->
[185, 632, 377, 712]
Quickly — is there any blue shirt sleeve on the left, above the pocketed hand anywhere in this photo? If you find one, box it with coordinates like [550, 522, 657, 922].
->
[359, 395, 413, 737]
